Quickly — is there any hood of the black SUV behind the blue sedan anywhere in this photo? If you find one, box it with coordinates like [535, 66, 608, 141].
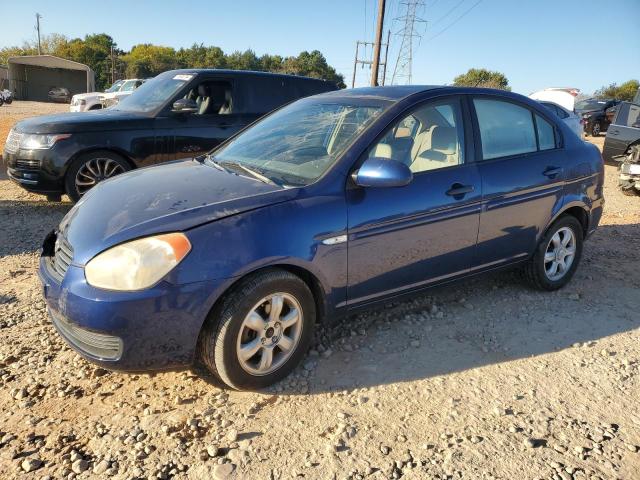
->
[14, 109, 153, 134]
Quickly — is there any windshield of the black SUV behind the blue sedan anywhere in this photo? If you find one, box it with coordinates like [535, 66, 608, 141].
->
[111, 72, 195, 113]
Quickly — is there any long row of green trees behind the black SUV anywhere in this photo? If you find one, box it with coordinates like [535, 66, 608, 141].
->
[0, 33, 345, 90]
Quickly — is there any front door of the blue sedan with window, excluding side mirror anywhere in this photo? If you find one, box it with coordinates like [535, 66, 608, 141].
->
[347, 97, 481, 304]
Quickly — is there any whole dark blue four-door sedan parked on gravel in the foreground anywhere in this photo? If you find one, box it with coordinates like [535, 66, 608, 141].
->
[39, 86, 604, 389]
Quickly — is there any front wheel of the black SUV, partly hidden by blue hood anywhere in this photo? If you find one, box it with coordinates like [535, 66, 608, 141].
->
[64, 150, 131, 202]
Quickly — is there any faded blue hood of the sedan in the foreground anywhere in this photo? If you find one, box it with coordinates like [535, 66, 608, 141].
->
[59, 160, 300, 265]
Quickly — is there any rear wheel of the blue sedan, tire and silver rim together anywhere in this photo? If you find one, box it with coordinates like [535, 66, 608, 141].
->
[523, 215, 583, 290]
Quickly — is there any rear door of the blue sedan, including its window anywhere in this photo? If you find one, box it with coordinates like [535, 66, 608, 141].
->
[471, 96, 565, 269]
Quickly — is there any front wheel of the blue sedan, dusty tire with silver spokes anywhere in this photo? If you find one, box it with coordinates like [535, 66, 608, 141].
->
[198, 269, 316, 390]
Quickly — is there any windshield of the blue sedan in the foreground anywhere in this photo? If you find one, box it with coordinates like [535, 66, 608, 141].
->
[213, 101, 382, 186]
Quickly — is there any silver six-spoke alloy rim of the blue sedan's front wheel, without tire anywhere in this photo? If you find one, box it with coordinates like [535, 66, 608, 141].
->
[236, 293, 303, 376]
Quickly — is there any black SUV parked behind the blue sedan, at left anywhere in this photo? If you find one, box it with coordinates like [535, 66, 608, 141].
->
[3, 69, 338, 201]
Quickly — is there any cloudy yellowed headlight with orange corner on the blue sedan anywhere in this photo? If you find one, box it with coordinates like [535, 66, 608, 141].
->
[84, 233, 191, 291]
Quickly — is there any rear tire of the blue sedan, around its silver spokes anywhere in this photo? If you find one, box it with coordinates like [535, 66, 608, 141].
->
[523, 215, 583, 291]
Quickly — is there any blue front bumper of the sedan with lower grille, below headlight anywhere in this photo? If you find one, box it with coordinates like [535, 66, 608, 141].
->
[38, 244, 225, 371]
